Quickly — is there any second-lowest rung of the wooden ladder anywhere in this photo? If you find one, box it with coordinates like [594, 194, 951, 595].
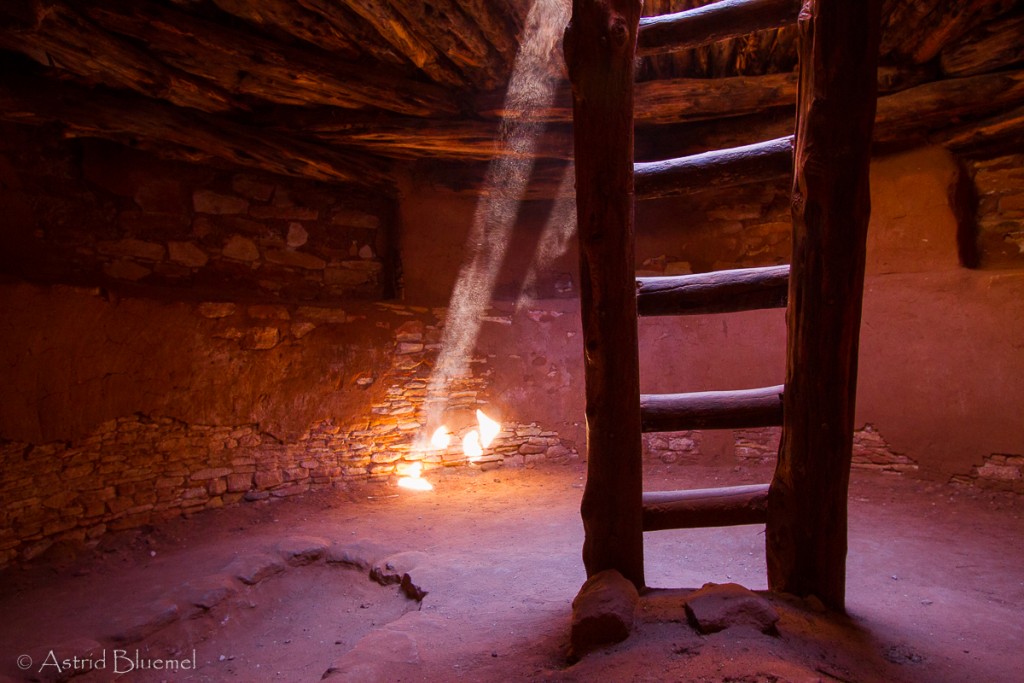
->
[640, 384, 784, 432]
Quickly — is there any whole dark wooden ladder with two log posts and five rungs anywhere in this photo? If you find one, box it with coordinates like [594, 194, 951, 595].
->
[565, 0, 881, 610]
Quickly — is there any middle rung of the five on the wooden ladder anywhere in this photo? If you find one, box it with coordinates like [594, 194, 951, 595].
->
[637, 265, 790, 315]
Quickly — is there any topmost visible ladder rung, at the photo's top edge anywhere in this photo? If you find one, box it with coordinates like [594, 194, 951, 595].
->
[637, 0, 802, 56]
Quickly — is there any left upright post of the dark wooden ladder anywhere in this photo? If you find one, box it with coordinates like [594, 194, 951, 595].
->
[565, 0, 644, 589]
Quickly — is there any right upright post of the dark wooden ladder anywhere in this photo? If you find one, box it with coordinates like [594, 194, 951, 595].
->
[766, 0, 881, 611]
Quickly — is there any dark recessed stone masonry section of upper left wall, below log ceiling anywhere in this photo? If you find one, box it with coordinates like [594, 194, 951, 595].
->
[0, 129, 394, 301]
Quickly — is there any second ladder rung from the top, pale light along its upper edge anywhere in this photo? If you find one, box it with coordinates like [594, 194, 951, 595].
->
[633, 135, 793, 200]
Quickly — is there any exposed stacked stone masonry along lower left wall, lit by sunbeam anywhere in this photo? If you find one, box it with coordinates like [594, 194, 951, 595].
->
[0, 288, 578, 565]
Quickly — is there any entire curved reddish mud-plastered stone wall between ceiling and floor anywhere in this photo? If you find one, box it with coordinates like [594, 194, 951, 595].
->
[0, 126, 1024, 562]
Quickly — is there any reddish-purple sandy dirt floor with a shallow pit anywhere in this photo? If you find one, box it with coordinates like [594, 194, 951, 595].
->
[0, 463, 1024, 683]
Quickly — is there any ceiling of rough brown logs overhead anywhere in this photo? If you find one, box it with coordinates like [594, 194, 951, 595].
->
[0, 0, 1024, 196]
